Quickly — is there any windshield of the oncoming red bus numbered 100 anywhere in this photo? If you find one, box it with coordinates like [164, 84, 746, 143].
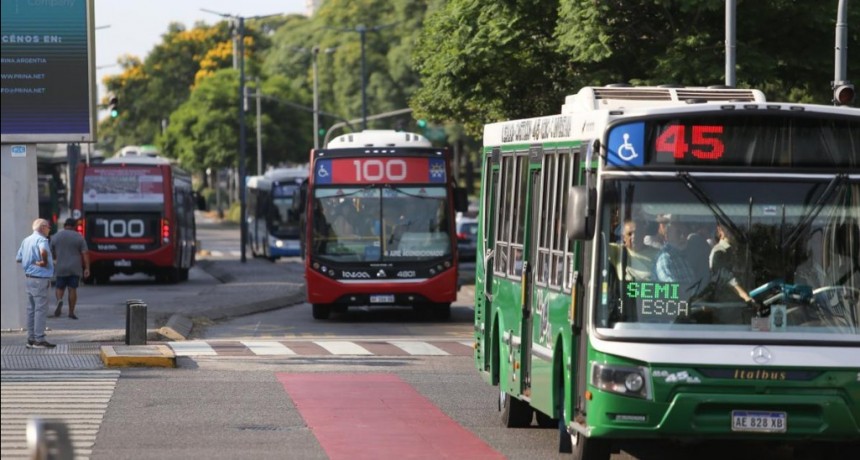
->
[312, 186, 452, 262]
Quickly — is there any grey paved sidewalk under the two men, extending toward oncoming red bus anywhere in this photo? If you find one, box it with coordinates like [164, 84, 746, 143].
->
[0, 252, 305, 370]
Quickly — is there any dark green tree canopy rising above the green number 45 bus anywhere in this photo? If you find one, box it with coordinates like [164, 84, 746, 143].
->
[411, 0, 860, 136]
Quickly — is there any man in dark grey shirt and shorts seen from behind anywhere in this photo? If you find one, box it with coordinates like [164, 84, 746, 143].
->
[51, 217, 90, 319]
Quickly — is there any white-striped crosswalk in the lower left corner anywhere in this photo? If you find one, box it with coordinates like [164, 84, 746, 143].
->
[0, 370, 120, 459]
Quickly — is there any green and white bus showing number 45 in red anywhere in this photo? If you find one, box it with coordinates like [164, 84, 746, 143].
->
[475, 86, 860, 459]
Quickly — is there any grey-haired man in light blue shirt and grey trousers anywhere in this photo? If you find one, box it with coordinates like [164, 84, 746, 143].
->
[15, 219, 56, 348]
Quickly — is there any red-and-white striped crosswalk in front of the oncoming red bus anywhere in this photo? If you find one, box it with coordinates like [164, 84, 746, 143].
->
[167, 339, 473, 357]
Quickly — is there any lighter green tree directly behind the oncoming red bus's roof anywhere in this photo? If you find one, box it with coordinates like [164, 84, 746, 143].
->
[263, 0, 430, 137]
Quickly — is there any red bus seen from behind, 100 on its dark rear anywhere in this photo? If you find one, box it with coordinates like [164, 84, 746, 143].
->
[72, 155, 197, 284]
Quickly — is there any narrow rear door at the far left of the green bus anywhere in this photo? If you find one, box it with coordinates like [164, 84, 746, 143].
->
[475, 148, 501, 378]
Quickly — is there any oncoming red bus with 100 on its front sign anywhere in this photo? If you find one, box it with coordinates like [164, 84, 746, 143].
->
[305, 130, 467, 319]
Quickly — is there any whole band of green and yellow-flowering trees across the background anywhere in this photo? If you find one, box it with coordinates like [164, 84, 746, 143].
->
[99, 0, 860, 178]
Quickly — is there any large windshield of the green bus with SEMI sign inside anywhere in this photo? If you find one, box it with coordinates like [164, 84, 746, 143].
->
[594, 174, 860, 342]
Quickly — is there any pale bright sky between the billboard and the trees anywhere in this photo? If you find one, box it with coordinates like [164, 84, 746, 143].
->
[93, 0, 307, 98]
